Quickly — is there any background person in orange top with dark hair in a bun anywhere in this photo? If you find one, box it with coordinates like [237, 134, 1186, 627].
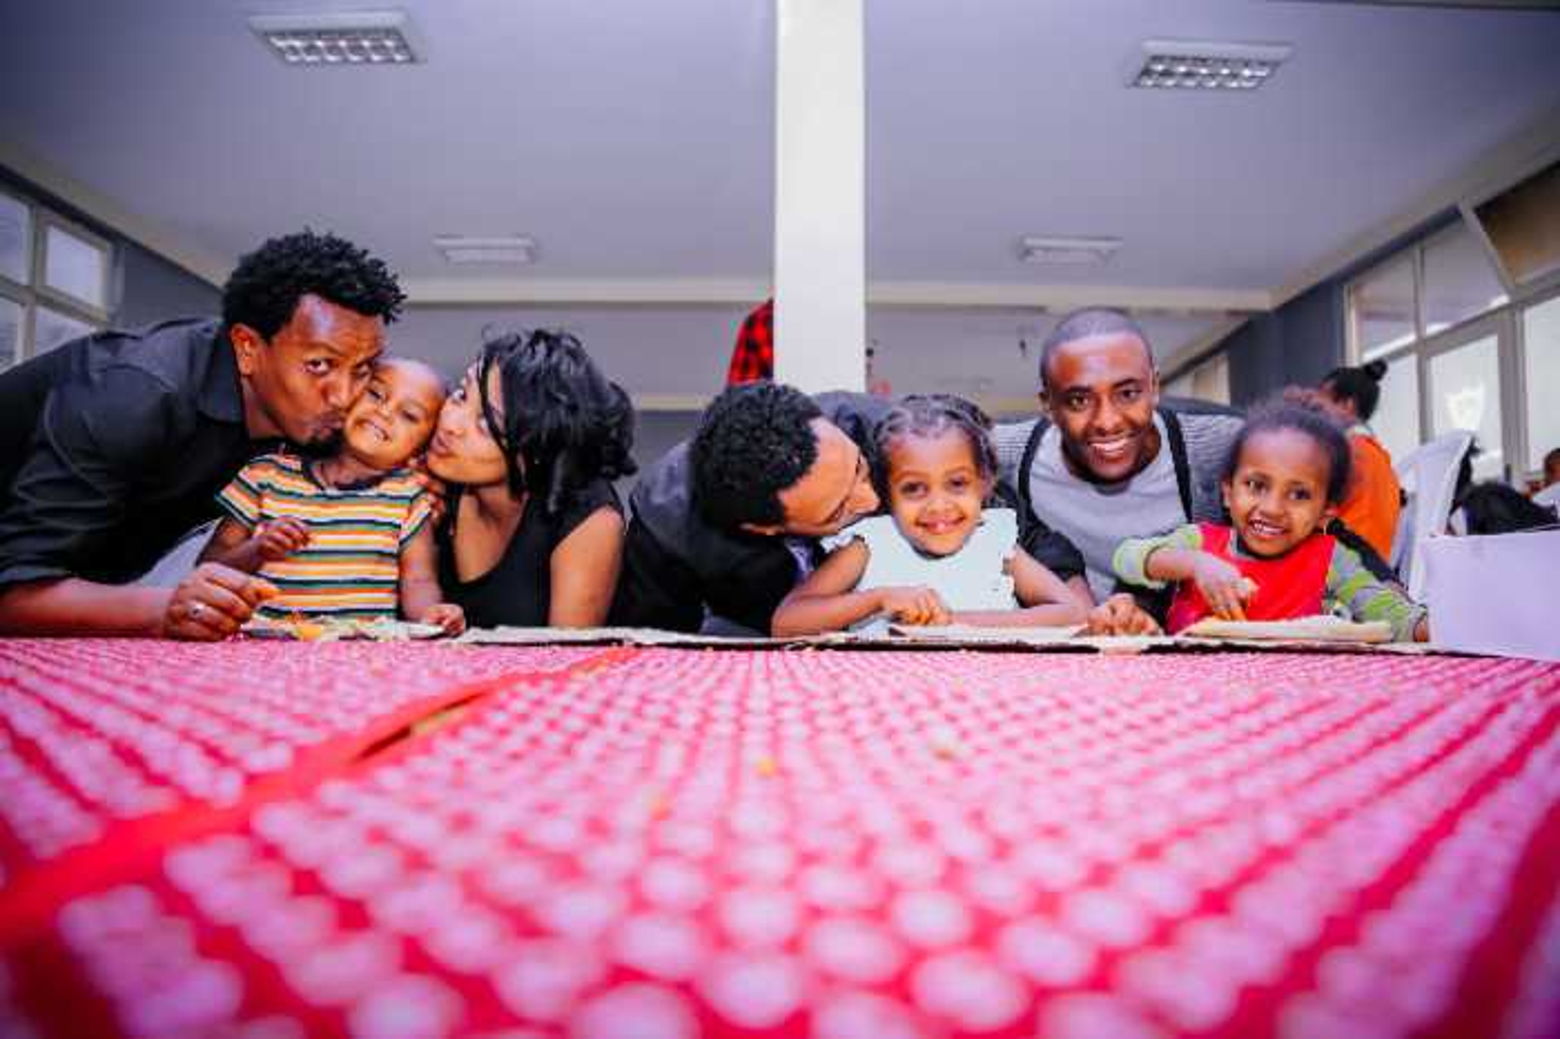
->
[1320, 360, 1402, 559]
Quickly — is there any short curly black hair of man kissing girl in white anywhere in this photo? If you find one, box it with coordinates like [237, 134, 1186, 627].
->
[690, 382, 824, 530]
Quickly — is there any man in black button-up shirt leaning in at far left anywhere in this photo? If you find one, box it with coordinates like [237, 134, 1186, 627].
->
[0, 231, 404, 640]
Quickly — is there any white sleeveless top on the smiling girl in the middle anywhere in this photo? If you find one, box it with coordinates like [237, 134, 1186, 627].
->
[824, 509, 1019, 610]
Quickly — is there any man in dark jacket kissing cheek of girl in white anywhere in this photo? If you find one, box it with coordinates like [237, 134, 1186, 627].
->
[612, 382, 888, 635]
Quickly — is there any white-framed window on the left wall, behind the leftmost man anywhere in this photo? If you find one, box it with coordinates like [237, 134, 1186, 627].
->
[0, 189, 114, 370]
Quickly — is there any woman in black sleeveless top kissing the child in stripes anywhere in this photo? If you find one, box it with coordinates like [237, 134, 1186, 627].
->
[427, 331, 635, 627]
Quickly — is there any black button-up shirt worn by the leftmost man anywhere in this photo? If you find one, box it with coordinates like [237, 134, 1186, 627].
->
[0, 320, 265, 585]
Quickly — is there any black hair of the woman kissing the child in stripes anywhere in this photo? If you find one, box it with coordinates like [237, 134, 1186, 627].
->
[477, 329, 638, 513]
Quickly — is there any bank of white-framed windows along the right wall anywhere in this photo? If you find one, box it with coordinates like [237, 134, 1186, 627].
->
[1346, 213, 1560, 484]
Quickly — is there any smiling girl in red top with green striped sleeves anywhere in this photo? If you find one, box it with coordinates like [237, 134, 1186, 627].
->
[1114, 401, 1429, 641]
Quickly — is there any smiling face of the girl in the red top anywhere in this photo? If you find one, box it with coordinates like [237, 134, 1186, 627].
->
[1223, 429, 1335, 557]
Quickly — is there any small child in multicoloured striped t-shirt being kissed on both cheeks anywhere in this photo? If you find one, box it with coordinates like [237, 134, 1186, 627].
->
[201, 357, 465, 635]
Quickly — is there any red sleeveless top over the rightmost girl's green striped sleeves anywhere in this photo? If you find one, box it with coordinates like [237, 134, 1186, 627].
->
[1165, 523, 1335, 635]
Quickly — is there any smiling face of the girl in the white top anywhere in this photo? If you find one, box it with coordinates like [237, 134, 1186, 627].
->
[888, 429, 991, 555]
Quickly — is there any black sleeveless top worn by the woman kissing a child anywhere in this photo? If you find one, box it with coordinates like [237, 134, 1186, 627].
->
[435, 479, 622, 627]
